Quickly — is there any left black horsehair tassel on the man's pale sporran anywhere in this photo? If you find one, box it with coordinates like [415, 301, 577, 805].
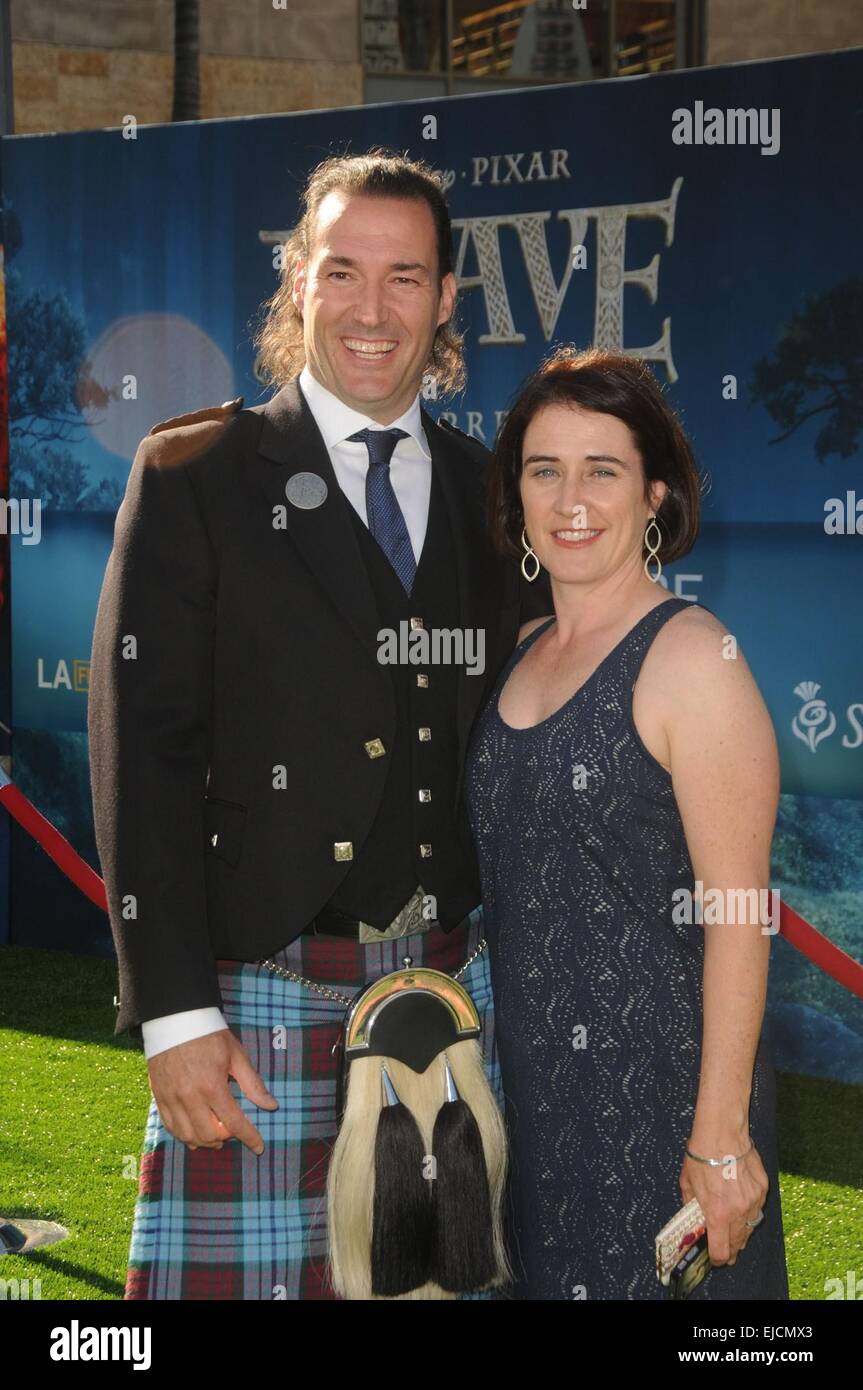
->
[371, 1062, 434, 1298]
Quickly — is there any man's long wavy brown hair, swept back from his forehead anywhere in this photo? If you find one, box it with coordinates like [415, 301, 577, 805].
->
[253, 146, 466, 395]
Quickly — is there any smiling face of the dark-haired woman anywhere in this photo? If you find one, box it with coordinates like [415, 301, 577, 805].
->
[520, 406, 667, 584]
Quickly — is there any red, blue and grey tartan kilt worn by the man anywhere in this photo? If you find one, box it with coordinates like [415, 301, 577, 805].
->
[124, 906, 503, 1300]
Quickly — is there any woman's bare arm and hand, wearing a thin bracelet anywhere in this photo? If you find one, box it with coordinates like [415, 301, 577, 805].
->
[655, 610, 780, 1264]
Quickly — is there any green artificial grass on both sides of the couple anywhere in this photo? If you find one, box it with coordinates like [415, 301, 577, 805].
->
[0, 947, 863, 1300]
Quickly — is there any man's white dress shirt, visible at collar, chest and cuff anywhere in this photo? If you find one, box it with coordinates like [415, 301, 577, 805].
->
[140, 367, 432, 1061]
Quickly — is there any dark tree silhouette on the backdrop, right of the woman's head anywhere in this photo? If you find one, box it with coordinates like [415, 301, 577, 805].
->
[749, 277, 863, 461]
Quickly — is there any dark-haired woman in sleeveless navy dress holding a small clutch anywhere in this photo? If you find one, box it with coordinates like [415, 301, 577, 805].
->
[466, 349, 788, 1300]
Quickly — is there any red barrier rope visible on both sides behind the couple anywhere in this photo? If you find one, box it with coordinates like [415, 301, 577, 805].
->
[0, 783, 863, 998]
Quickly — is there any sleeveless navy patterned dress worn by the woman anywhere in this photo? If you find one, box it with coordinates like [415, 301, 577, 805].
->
[466, 599, 788, 1300]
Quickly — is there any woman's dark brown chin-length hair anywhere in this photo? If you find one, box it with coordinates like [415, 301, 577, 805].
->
[488, 345, 700, 564]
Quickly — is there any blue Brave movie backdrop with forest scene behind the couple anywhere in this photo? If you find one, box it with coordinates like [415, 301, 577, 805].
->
[0, 50, 863, 1083]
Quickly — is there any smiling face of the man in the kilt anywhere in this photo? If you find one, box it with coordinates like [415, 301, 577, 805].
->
[293, 190, 456, 424]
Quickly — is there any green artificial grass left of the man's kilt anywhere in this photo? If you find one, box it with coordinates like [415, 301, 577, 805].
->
[0, 947, 150, 1300]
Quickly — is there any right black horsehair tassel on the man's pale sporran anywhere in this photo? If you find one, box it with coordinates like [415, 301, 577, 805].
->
[432, 1054, 496, 1293]
